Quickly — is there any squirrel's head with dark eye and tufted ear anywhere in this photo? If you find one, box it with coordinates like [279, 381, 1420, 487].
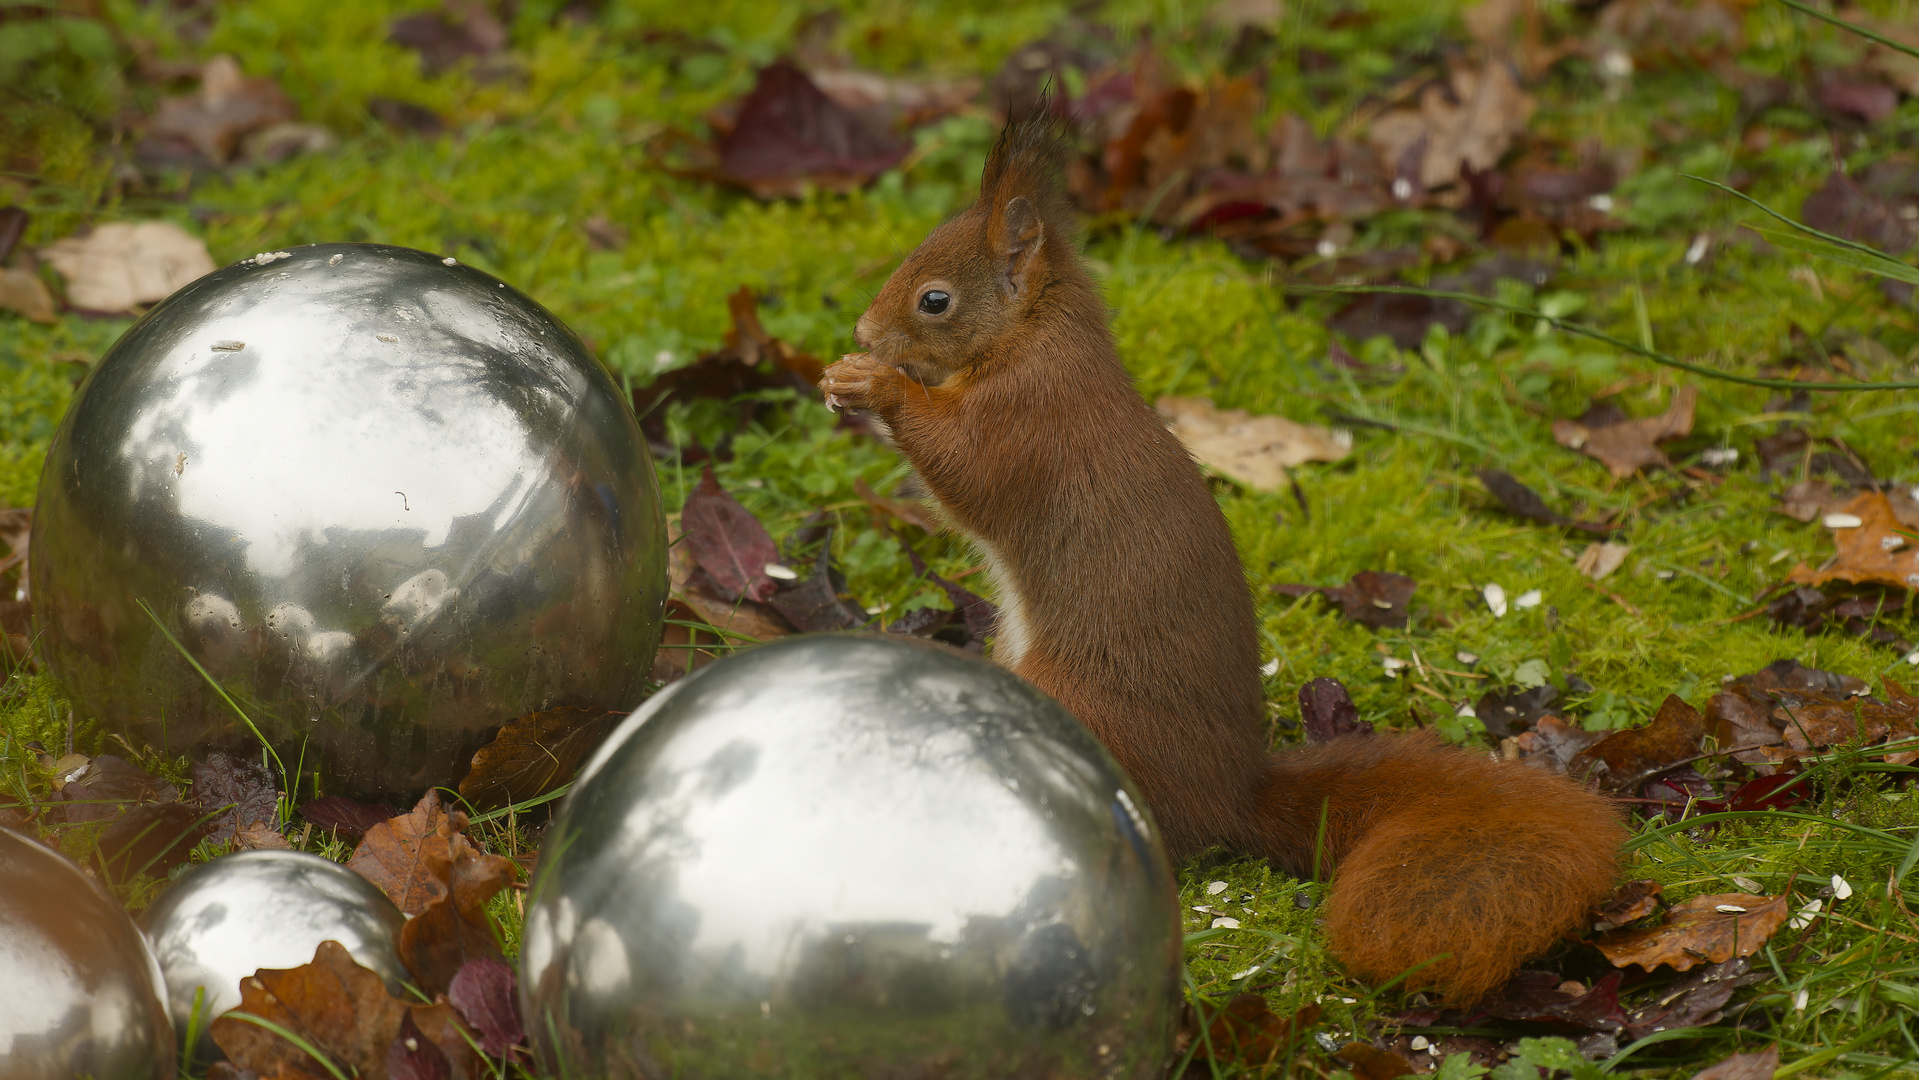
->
[856, 112, 1084, 386]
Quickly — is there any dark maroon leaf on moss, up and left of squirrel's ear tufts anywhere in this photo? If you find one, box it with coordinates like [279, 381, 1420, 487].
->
[714, 59, 913, 200]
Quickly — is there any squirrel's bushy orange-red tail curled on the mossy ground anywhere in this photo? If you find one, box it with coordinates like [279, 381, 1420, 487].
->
[1242, 733, 1625, 1003]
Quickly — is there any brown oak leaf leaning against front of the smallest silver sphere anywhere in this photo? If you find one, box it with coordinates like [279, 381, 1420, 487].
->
[209, 942, 407, 1076]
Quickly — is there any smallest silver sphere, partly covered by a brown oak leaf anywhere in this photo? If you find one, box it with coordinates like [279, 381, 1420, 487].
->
[140, 852, 407, 1061]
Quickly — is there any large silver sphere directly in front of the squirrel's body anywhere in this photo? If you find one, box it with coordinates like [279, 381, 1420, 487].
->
[520, 635, 1180, 1080]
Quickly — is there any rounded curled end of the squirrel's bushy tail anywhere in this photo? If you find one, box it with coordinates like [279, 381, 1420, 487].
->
[1326, 763, 1625, 1005]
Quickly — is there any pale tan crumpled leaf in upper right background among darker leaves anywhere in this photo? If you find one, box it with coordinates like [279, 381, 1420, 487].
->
[1370, 61, 1535, 188]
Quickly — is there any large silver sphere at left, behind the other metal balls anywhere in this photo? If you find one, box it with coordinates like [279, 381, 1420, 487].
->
[31, 244, 666, 804]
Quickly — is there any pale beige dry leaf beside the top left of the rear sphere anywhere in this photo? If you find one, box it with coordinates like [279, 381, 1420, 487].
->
[40, 221, 213, 311]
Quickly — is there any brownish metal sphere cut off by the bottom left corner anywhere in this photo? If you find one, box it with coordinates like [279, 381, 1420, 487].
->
[0, 829, 175, 1080]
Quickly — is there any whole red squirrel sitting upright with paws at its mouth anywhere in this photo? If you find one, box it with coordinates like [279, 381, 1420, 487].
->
[819, 119, 1625, 1003]
